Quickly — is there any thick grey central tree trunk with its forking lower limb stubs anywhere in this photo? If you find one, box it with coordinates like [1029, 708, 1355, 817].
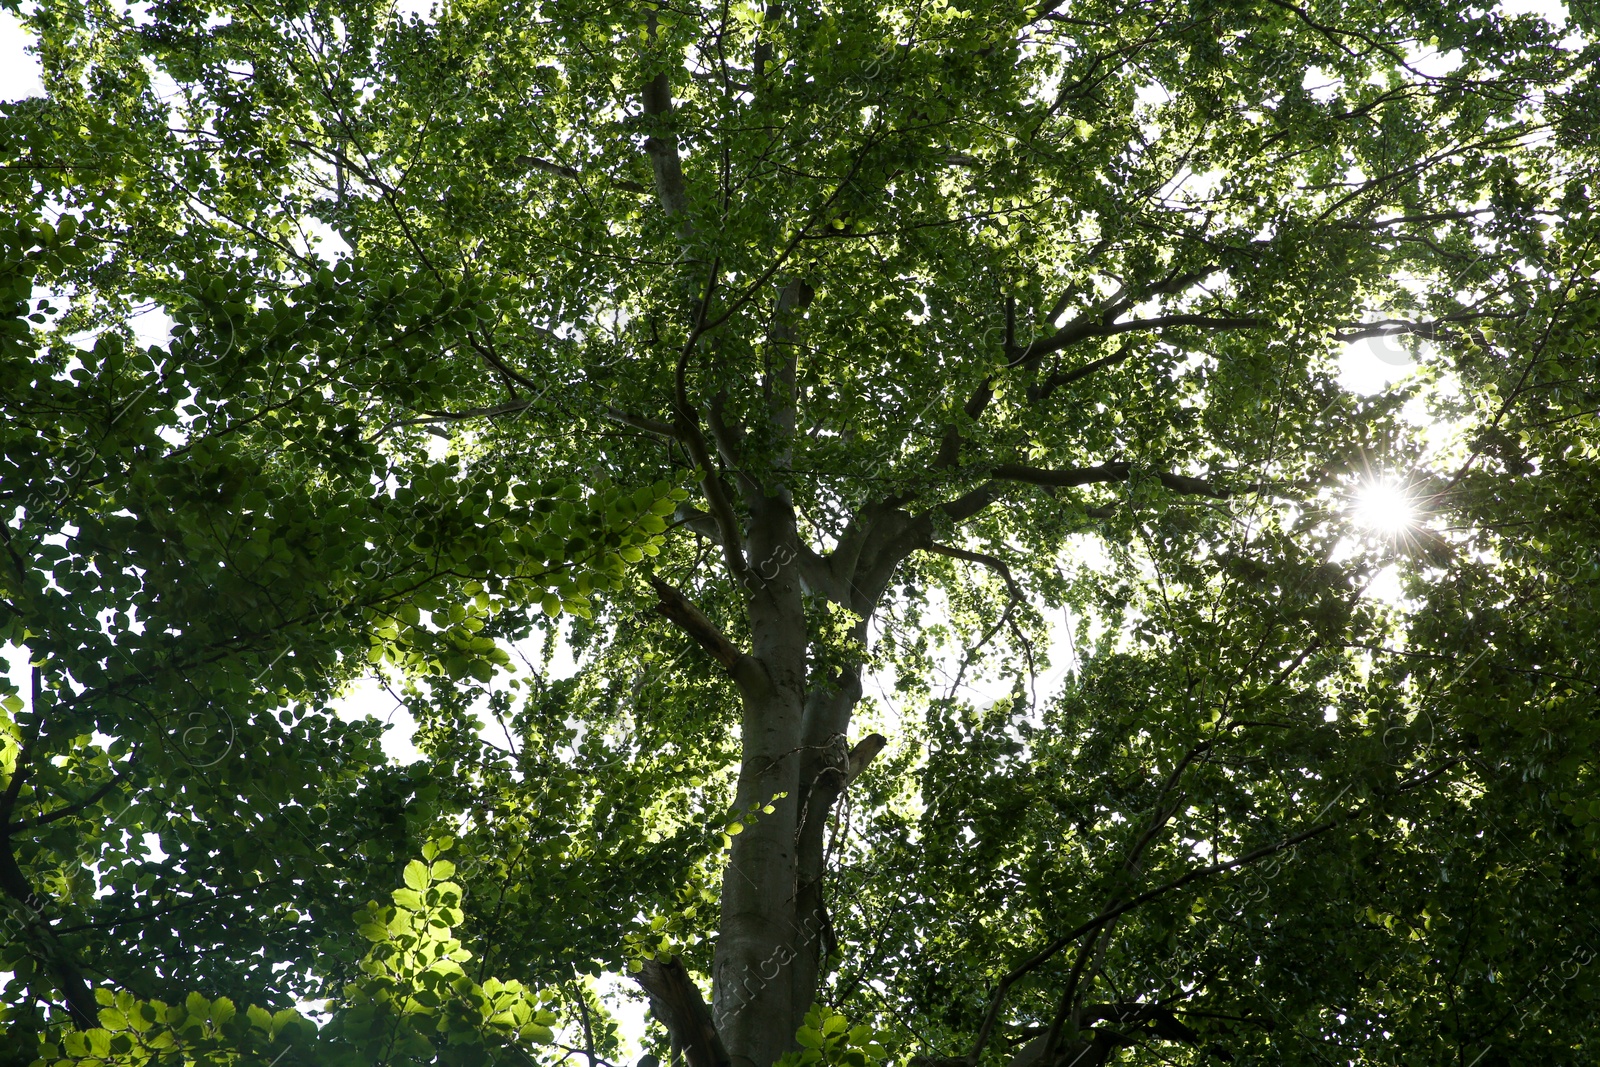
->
[658, 348, 930, 1067]
